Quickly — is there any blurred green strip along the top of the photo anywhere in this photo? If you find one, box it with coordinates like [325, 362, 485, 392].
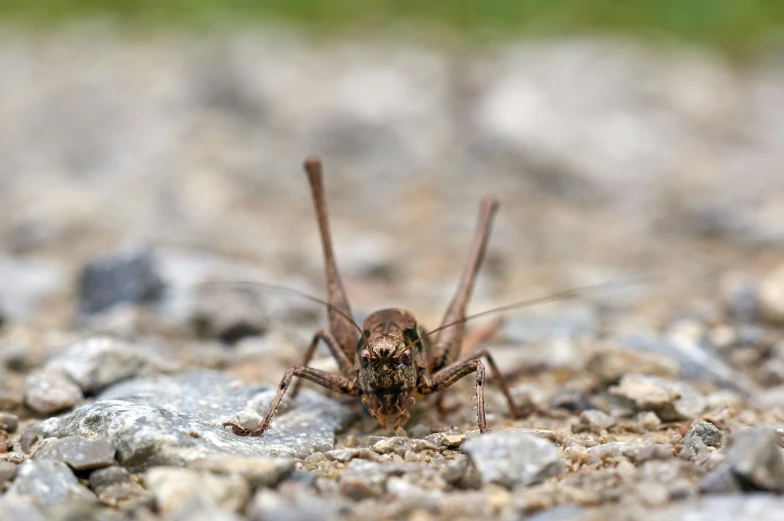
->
[0, 0, 784, 54]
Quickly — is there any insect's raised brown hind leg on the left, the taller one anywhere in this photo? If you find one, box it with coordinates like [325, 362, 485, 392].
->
[305, 157, 357, 360]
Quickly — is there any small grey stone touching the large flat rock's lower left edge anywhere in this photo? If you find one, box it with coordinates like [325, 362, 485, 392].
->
[33, 436, 117, 470]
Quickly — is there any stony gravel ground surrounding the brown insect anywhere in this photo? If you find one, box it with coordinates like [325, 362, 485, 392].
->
[0, 26, 784, 521]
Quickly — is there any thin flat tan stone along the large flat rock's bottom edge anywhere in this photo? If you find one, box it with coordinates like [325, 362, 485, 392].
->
[188, 456, 294, 488]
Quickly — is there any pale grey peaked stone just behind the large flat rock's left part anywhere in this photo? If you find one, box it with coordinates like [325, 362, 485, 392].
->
[46, 336, 175, 394]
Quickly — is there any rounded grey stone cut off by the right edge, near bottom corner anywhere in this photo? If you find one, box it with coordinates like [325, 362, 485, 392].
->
[727, 427, 784, 492]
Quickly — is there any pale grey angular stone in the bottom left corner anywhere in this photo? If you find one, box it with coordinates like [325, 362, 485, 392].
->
[8, 460, 96, 505]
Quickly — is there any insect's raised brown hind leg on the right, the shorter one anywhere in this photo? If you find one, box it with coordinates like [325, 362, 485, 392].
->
[430, 197, 498, 372]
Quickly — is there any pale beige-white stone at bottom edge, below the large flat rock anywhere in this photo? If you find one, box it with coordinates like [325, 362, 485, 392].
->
[144, 467, 251, 515]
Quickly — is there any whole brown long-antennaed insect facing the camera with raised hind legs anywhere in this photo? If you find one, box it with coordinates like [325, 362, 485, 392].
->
[223, 157, 640, 436]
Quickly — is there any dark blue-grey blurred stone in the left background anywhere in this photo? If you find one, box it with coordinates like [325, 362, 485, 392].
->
[79, 248, 164, 314]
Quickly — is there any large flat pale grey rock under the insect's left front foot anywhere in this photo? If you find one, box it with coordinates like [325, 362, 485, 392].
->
[39, 371, 353, 469]
